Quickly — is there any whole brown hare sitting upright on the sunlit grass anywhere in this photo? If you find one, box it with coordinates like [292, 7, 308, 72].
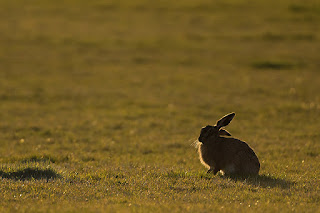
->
[198, 113, 260, 176]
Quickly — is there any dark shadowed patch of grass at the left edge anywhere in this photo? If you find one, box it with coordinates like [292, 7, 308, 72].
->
[0, 168, 60, 180]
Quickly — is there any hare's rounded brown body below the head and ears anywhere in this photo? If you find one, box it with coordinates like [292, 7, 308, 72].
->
[198, 137, 260, 175]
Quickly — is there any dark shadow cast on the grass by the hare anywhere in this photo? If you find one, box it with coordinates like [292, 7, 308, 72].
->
[224, 175, 295, 189]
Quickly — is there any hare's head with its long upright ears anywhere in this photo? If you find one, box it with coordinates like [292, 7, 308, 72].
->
[198, 112, 236, 143]
